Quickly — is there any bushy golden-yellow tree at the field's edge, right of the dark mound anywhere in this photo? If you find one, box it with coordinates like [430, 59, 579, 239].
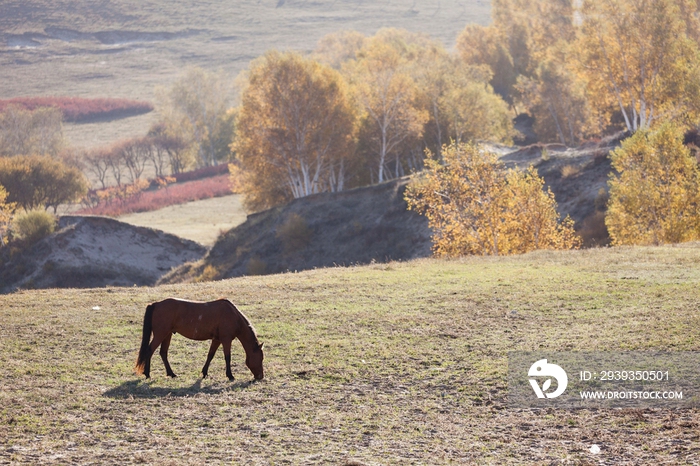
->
[405, 143, 580, 257]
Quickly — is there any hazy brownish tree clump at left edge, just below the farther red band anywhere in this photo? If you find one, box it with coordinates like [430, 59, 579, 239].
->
[0, 105, 65, 156]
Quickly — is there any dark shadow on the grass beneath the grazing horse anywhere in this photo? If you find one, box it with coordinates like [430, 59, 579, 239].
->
[102, 379, 256, 399]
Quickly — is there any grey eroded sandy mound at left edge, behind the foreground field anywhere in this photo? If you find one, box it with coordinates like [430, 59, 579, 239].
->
[0, 216, 206, 293]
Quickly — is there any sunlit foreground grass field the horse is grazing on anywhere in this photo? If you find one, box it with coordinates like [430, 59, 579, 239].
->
[0, 244, 700, 465]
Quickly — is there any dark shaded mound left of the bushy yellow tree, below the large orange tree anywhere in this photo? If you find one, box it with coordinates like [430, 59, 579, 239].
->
[161, 178, 431, 283]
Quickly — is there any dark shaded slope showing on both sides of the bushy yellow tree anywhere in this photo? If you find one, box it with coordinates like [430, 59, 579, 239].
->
[161, 138, 617, 283]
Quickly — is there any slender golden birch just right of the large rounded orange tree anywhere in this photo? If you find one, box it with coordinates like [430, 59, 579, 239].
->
[346, 32, 429, 183]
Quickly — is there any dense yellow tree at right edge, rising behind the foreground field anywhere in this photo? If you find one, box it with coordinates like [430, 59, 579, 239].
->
[605, 123, 700, 245]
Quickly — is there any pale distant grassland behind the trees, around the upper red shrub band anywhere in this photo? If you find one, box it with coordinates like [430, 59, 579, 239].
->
[0, 0, 491, 147]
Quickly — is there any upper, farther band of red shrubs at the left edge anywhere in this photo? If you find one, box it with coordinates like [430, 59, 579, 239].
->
[0, 97, 153, 122]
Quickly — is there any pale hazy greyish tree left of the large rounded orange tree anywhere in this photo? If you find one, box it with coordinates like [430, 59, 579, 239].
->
[157, 67, 230, 167]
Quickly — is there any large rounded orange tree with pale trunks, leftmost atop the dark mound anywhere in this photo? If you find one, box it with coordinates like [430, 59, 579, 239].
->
[233, 51, 356, 209]
